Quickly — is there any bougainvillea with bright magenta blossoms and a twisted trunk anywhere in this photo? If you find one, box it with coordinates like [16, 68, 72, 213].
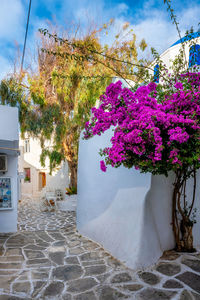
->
[84, 73, 200, 251]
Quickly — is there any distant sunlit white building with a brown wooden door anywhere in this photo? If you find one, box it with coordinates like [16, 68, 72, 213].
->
[19, 134, 69, 198]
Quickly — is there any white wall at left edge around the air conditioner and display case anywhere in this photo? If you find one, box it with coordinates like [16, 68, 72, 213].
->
[0, 105, 19, 233]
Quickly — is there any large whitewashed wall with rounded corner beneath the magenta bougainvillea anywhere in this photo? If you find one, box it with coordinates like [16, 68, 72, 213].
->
[77, 130, 200, 269]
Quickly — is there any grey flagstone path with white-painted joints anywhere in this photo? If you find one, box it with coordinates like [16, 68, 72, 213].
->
[0, 200, 200, 300]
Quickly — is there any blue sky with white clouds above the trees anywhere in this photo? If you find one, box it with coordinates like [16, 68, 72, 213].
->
[0, 0, 200, 78]
